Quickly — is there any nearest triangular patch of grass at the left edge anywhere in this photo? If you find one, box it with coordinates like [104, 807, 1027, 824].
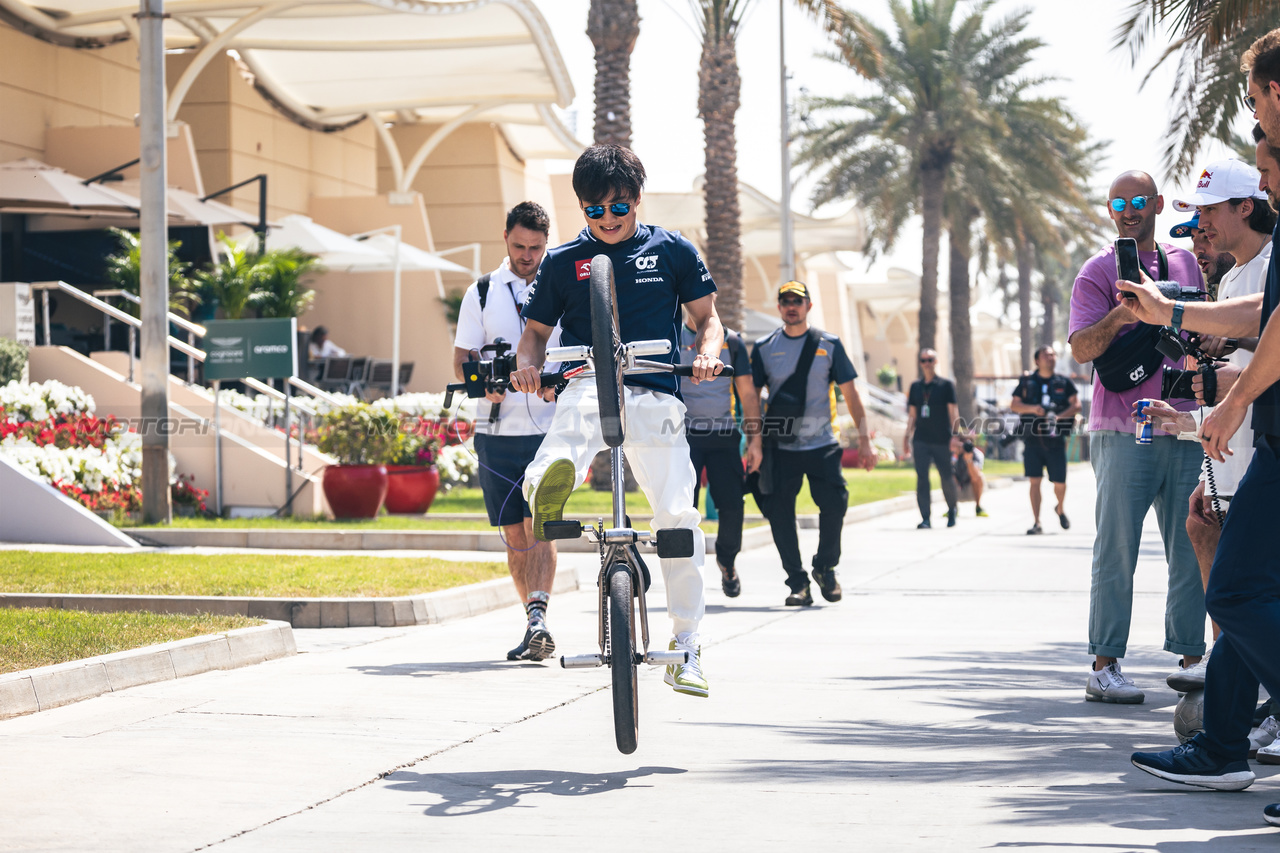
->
[0, 607, 262, 672]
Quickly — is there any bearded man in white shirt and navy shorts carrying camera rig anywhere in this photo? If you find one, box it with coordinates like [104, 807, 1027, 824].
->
[453, 201, 556, 661]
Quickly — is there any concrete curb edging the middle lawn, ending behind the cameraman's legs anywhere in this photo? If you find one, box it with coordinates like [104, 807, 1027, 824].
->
[0, 560, 579, 627]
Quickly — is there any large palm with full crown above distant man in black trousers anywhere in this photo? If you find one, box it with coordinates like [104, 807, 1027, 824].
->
[796, 0, 1036, 347]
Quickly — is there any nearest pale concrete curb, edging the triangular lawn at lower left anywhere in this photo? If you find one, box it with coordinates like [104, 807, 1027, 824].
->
[0, 621, 298, 720]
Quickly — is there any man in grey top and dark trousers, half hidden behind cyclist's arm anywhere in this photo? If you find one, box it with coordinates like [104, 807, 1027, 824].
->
[680, 315, 762, 598]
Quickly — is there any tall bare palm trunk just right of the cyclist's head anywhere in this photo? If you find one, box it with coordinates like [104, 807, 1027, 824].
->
[690, 0, 847, 329]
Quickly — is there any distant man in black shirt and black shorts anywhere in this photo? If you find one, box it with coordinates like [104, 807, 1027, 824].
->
[1010, 346, 1080, 535]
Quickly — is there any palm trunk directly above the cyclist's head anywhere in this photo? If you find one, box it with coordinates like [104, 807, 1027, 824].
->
[586, 0, 640, 149]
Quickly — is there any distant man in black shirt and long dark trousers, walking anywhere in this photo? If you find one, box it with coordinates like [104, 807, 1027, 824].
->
[902, 350, 960, 530]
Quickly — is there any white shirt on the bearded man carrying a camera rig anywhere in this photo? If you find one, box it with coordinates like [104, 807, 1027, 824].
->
[453, 257, 559, 435]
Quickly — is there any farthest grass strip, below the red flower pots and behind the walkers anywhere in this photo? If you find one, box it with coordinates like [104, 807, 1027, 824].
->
[137, 460, 1023, 533]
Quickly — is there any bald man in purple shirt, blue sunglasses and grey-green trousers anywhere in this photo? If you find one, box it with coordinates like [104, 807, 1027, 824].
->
[1068, 172, 1204, 704]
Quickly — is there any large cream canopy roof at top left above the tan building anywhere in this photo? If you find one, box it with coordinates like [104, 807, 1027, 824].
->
[0, 0, 581, 158]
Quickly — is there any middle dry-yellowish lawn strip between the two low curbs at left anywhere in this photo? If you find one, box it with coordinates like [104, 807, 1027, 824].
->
[0, 551, 507, 594]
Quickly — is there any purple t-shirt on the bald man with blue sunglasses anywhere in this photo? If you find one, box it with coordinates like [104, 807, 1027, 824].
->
[1066, 243, 1204, 432]
